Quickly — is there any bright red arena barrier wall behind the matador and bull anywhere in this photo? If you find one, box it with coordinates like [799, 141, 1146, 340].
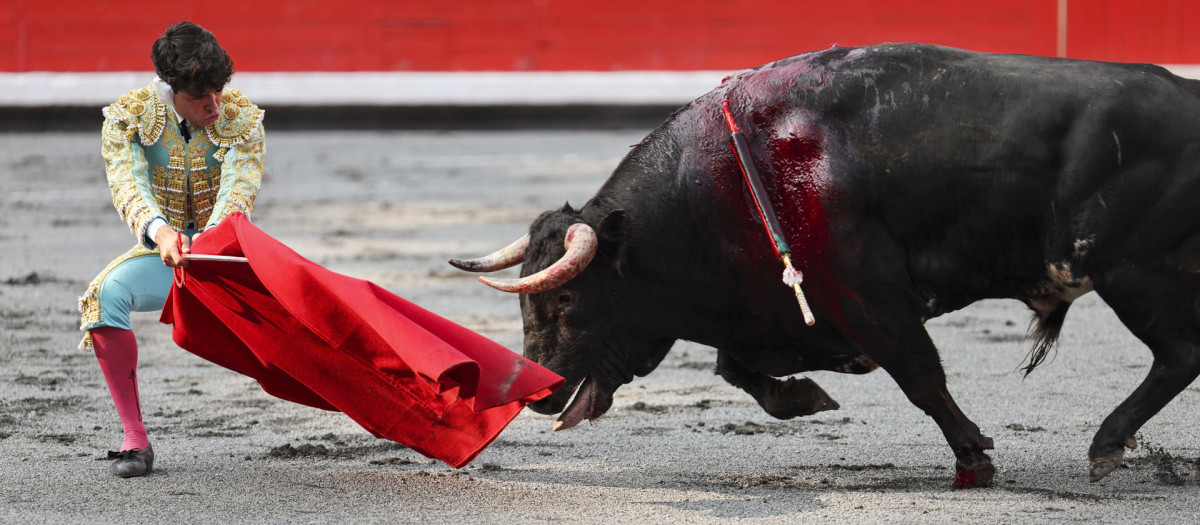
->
[0, 0, 1200, 71]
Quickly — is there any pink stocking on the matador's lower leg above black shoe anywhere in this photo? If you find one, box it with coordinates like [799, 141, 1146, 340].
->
[91, 326, 150, 451]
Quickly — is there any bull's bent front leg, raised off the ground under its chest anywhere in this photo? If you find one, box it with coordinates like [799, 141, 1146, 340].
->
[716, 349, 839, 420]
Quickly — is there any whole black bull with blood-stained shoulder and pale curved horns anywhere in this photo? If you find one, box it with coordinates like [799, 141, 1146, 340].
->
[452, 46, 1200, 487]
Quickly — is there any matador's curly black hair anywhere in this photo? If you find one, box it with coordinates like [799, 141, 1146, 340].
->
[150, 22, 233, 98]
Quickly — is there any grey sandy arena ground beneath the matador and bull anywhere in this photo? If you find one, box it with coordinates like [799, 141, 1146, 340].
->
[0, 128, 1200, 524]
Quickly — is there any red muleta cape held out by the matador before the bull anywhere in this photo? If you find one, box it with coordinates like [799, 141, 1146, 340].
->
[160, 213, 563, 467]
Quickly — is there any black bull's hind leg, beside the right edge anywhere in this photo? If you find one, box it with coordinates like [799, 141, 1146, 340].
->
[1087, 268, 1200, 482]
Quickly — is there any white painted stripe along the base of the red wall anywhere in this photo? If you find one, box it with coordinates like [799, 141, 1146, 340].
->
[0, 65, 1200, 108]
